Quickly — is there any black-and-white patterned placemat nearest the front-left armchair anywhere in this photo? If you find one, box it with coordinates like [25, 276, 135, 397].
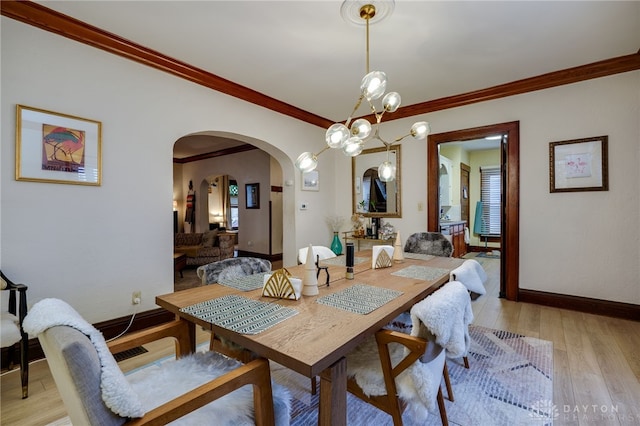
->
[180, 294, 298, 334]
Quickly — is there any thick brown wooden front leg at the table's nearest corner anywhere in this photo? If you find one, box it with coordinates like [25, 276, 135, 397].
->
[318, 358, 347, 426]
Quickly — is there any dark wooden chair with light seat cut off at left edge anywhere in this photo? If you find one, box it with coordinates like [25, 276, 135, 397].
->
[0, 271, 29, 399]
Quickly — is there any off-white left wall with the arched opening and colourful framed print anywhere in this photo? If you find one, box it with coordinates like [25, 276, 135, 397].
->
[0, 17, 334, 322]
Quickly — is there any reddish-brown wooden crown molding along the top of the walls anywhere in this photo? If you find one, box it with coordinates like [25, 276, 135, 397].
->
[0, 1, 640, 128]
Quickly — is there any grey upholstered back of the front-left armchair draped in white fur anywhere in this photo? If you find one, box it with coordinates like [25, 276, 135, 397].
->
[38, 326, 127, 426]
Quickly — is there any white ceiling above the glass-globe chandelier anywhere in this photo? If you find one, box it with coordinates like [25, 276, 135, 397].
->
[39, 0, 640, 156]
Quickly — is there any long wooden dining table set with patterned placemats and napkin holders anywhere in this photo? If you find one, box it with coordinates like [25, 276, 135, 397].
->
[156, 250, 463, 426]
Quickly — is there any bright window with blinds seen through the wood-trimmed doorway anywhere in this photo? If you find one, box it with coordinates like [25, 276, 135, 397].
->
[480, 166, 502, 235]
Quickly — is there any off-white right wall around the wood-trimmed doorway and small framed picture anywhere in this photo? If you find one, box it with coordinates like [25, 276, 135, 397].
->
[338, 71, 640, 304]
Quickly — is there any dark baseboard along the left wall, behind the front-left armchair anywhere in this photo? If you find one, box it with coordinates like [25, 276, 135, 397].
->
[2, 308, 175, 371]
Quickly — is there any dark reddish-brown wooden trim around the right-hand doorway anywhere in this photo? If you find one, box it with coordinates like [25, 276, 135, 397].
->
[427, 121, 520, 301]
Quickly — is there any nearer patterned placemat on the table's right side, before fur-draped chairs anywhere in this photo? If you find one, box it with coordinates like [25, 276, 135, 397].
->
[316, 284, 402, 315]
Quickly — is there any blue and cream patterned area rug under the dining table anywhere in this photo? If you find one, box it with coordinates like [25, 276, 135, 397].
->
[49, 325, 556, 426]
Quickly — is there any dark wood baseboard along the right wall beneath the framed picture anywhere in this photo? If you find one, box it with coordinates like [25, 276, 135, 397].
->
[518, 289, 640, 321]
